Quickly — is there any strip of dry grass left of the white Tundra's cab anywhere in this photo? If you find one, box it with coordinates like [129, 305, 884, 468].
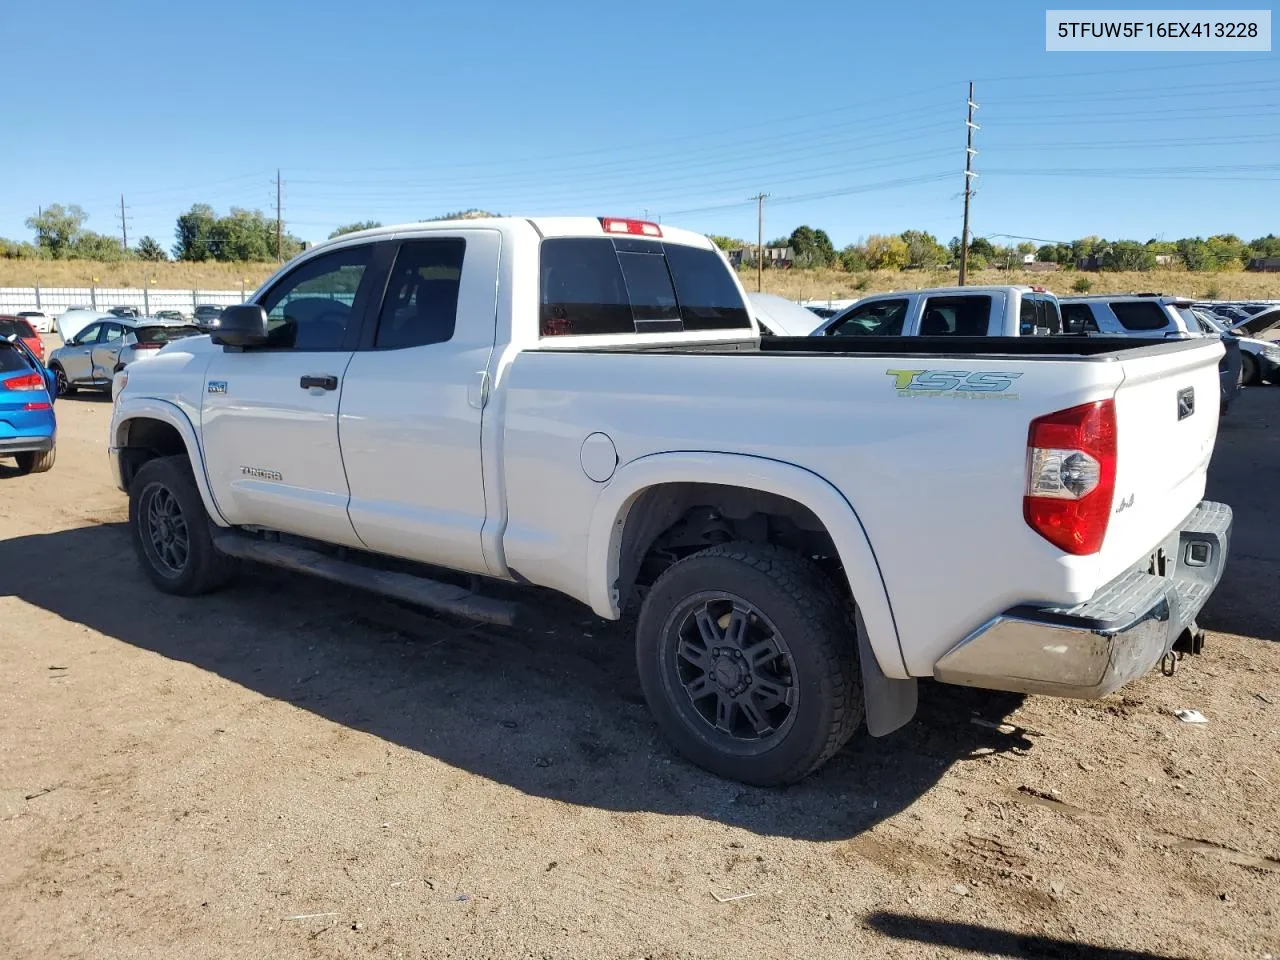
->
[0, 260, 276, 291]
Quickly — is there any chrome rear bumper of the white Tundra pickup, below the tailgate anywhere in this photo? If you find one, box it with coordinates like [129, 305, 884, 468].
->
[933, 500, 1231, 699]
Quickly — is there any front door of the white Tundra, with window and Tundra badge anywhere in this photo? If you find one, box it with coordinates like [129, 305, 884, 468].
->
[201, 243, 385, 547]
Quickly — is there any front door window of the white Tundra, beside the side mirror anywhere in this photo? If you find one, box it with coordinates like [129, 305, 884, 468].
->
[260, 244, 372, 351]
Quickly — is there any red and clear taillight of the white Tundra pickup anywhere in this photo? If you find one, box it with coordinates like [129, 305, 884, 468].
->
[1023, 399, 1116, 556]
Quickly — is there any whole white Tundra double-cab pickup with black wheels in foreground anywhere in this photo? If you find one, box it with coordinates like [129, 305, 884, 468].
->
[110, 218, 1231, 783]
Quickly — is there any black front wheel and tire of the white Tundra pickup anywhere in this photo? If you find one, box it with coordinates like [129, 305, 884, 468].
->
[129, 456, 232, 596]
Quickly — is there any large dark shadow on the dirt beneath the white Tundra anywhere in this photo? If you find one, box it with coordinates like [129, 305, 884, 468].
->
[0, 524, 1033, 840]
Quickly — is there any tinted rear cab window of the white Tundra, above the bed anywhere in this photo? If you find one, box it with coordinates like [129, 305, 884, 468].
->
[538, 237, 753, 337]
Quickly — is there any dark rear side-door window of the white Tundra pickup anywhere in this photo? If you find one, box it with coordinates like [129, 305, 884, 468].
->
[374, 237, 467, 349]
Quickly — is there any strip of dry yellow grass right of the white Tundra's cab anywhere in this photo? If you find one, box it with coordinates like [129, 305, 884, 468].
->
[740, 264, 1280, 300]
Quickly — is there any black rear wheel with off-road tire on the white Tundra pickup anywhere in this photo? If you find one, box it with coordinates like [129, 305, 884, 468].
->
[636, 543, 863, 786]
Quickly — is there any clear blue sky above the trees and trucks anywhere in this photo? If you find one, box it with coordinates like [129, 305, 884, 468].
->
[0, 0, 1280, 247]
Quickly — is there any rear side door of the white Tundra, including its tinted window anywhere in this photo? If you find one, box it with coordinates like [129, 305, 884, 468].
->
[338, 229, 502, 573]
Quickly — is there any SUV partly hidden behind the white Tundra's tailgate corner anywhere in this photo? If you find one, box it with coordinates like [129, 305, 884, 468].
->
[1061, 293, 1243, 413]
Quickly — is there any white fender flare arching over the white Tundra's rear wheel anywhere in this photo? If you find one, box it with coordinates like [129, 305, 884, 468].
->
[586, 451, 915, 685]
